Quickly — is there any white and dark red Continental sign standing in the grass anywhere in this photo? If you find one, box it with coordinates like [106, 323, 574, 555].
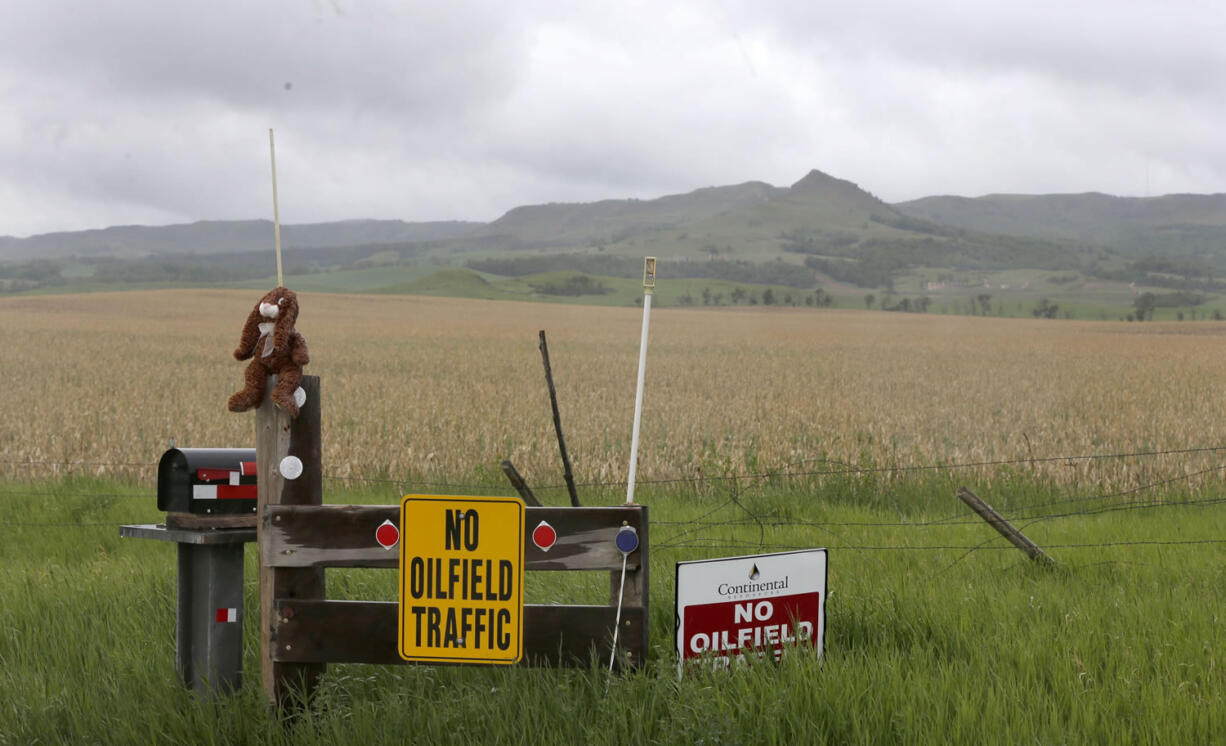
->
[677, 550, 826, 671]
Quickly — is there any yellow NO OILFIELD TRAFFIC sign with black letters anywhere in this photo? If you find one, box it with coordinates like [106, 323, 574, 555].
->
[400, 494, 524, 665]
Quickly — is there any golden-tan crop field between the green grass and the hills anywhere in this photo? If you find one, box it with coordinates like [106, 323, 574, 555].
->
[0, 290, 1226, 488]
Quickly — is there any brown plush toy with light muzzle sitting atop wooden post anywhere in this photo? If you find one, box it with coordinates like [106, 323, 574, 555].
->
[229, 287, 310, 417]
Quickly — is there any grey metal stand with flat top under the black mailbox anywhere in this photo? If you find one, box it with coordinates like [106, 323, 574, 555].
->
[119, 524, 256, 696]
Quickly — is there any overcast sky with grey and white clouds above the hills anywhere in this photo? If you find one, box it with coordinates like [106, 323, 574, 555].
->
[0, 0, 1226, 236]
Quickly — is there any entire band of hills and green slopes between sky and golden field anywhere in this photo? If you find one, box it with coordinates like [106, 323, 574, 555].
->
[11, 171, 1226, 319]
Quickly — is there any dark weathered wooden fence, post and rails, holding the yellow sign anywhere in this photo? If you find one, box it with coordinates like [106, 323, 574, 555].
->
[256, 375, 650, 703]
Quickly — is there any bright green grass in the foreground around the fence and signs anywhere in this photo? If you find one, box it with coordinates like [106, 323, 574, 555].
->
[0, 474, 1226, 745]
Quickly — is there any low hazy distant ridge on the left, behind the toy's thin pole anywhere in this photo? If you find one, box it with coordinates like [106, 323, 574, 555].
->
[0, 220, 482, 260]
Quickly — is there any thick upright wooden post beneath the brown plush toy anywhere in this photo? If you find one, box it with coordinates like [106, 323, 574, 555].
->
[255, 375, 325, 707]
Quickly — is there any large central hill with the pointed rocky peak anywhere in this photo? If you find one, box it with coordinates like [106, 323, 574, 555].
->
[460, 171, 1086, 287]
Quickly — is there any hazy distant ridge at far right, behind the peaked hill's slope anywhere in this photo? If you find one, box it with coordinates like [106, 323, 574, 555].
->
[894, 193, 1226, 260]
